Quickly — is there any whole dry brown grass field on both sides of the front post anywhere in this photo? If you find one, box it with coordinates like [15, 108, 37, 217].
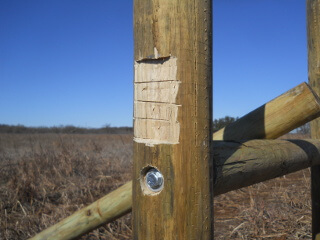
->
[0, 134, 311, 240]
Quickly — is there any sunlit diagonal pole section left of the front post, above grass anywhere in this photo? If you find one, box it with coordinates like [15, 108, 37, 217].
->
[31, 182, 132, 240]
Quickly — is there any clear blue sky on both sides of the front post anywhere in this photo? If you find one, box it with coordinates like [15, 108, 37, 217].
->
[0, 0, 308, 127]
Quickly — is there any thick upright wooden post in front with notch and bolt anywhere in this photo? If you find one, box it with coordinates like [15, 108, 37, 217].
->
[133, 0, 213, 240]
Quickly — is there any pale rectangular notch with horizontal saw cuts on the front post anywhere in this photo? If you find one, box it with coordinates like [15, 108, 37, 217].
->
[134, 57, 180, 146]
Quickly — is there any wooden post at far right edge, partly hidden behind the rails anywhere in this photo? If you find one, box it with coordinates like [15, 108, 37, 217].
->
[307, 0, 320, 239]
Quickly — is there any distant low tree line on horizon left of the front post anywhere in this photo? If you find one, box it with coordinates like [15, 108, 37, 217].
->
[0, 124, 133, 134]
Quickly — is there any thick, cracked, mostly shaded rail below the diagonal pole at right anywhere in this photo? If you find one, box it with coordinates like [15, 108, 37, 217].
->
[213, 140, 320, 196]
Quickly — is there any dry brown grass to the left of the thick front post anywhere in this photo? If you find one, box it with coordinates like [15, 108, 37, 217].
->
[0, 134, 132, 239]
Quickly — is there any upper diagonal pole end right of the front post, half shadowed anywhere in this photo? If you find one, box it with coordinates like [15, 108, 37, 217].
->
[213, 83, 320, 140]
